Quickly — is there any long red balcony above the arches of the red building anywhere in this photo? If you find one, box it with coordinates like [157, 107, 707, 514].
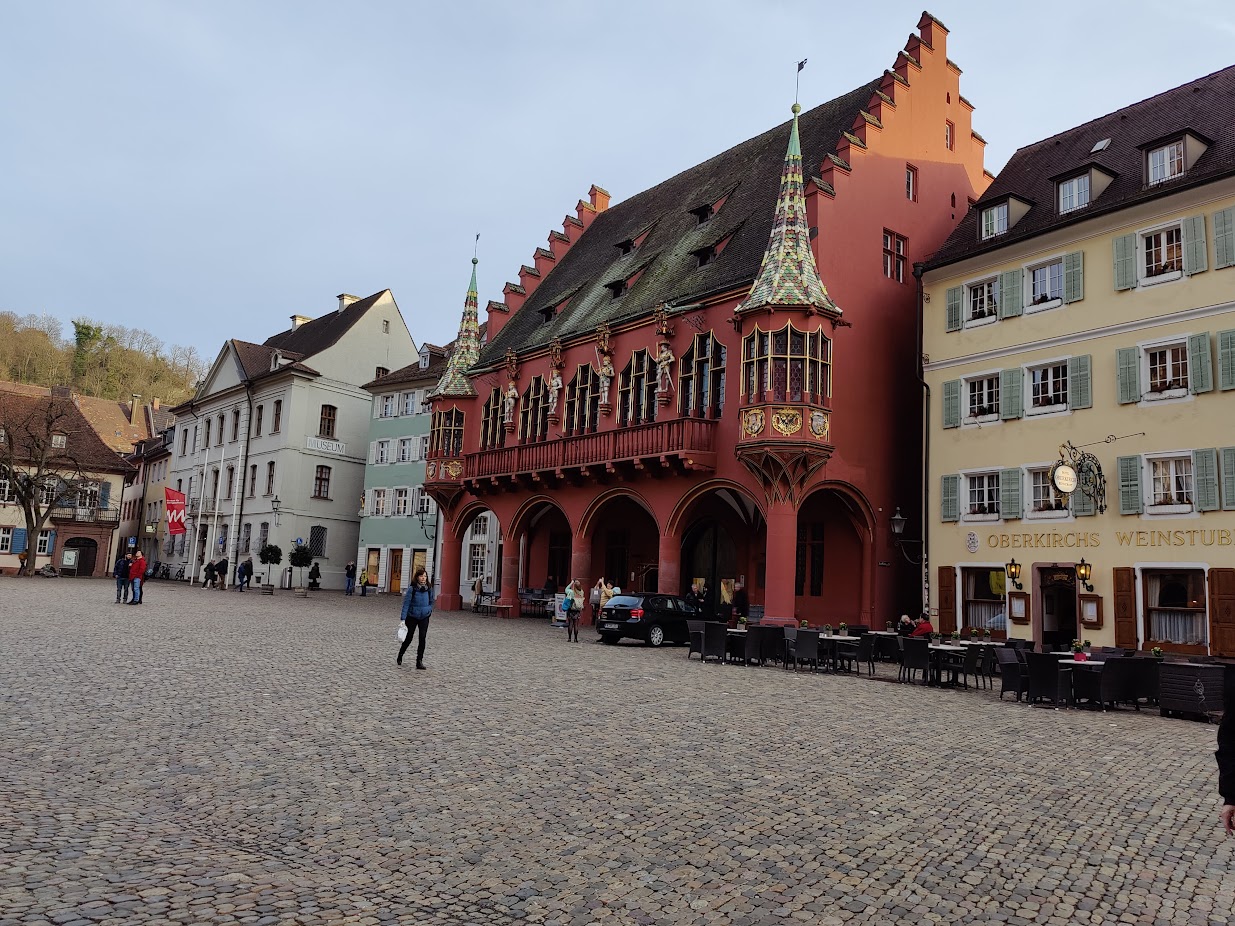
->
[459, 419, 716, 494]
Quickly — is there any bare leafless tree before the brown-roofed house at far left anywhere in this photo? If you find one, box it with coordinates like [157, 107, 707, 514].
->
[0, 393, 124, 575]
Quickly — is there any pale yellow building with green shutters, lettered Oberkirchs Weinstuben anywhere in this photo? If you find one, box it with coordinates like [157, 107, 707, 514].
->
[923, 68, 1235, 657]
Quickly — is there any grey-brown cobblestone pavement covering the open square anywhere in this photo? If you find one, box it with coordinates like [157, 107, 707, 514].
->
[0, 579, 1235, 926]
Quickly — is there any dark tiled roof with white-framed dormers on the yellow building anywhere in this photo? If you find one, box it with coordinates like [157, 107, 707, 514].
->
[927, 65, 1235, 268]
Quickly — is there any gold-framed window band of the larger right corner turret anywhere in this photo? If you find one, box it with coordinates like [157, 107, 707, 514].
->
[742, 323, 832, 405]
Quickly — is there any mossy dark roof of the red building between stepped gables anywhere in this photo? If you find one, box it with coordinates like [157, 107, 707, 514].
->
[478, 81, 879, 367]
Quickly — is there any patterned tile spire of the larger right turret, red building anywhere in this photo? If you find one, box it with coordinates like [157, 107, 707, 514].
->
[734, 103, 841, 315]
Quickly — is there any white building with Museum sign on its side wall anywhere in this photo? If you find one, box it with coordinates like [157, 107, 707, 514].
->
[168, 290, 417, 589]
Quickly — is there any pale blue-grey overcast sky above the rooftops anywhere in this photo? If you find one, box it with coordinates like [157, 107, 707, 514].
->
[0, 0, 1235, 359]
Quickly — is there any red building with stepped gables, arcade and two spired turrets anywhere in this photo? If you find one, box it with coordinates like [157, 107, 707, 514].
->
[426, 15, 989, 624]
